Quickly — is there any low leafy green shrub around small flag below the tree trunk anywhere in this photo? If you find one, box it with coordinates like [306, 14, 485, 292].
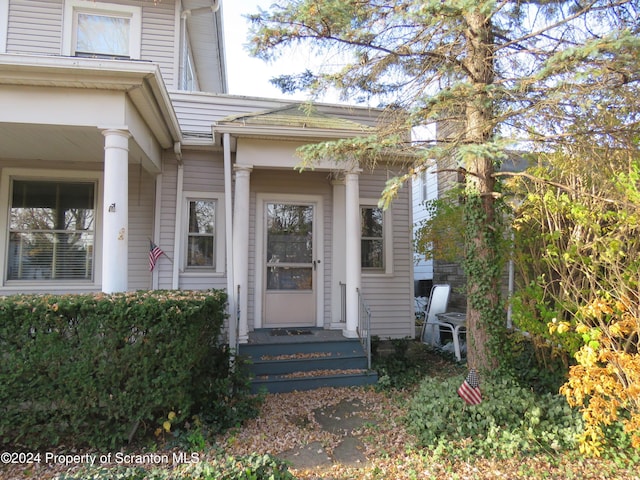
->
[407, 376, 581, 458]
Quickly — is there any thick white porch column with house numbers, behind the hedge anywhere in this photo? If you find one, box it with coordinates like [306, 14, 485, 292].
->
[102, 129, 131, 293]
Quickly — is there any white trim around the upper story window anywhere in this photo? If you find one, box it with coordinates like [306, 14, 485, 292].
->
[62, 0, 142, 60]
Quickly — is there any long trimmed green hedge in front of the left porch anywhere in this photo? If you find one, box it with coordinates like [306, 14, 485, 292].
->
[0, 291, 229, 449]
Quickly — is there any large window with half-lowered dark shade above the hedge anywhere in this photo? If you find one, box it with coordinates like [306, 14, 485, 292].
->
[7, 180, 96, 281]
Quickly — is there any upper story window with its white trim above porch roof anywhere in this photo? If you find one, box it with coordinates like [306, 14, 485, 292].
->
[63, 0, 142, 59]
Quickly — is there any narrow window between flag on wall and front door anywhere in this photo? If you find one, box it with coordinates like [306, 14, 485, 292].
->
[186, 199, 217, 269]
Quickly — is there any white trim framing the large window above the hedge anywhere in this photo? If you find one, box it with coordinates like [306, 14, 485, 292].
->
[0, 168, 103, 293]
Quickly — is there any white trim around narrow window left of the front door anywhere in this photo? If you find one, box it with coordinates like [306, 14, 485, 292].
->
[180, 191, 226, 277]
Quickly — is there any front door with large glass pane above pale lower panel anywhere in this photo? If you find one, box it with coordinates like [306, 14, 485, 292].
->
[263, 202, 317, 328]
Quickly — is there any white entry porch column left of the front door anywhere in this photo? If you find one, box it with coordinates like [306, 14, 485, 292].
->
[233, 165, 252, 343]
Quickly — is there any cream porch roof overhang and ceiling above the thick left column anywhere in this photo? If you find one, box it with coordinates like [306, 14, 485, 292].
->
[0, 54, 181, 172]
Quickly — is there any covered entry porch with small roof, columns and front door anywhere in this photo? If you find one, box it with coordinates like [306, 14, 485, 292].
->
[214, 107, 376, 344]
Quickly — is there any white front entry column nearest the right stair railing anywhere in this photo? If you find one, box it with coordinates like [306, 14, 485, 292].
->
[342, 170, 361, 338]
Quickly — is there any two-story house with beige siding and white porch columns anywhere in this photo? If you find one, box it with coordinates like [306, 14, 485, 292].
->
[0, 0, 414, 364]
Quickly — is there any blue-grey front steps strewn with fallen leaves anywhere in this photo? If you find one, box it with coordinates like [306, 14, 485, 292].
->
[239, 329, 378, 393]
